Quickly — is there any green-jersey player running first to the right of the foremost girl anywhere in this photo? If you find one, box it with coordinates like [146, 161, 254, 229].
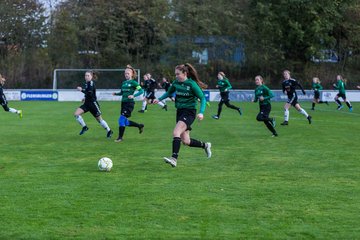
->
[212, 72, 242, 119]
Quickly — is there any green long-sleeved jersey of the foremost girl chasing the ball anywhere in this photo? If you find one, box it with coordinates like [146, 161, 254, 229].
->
[159, 78, 206, 113]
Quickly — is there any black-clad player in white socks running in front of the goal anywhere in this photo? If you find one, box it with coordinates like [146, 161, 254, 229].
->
[74, 71, 113, 138]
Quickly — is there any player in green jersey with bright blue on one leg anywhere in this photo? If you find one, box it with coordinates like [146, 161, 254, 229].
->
[113, 65, 144, 142]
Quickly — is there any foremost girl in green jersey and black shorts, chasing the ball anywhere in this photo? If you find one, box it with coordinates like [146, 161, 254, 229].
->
[153, 63, 211, 167]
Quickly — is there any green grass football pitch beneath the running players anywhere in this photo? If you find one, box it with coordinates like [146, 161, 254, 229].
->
[0, 102, 360, 239]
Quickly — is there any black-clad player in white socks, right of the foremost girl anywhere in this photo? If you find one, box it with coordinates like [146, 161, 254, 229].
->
[281, 70, 311, 125]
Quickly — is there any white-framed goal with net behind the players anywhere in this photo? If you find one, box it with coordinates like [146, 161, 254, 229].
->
[53, 68, 140, 91]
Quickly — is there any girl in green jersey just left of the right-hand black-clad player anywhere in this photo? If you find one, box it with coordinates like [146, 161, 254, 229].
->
[254, 75, 278, 137]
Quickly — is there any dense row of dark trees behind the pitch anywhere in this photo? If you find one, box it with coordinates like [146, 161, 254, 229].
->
[0, 0, 360, 88]
